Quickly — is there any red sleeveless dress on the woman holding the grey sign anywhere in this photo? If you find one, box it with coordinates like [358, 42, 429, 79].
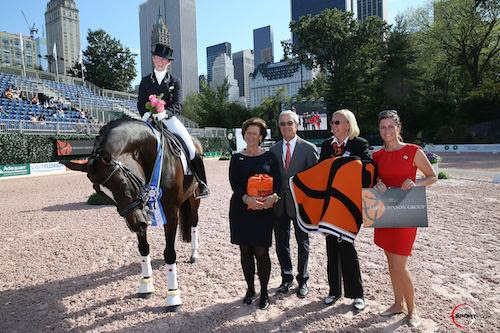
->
[373, 143, 420, 256]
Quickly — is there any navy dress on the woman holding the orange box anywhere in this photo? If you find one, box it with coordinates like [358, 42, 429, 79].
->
[229, 152, 280, 247]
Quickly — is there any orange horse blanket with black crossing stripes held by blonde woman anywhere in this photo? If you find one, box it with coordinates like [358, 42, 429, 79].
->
[289, 156, 376, 243]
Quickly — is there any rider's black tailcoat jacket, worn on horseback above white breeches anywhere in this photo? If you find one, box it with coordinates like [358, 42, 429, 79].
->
[137, 73, 182, 117]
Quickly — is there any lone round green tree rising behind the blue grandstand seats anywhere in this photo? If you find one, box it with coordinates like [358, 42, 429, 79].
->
[83, 29, 136, 91]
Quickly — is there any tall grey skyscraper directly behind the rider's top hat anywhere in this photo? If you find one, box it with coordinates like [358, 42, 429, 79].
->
[139, 0, 199, 100]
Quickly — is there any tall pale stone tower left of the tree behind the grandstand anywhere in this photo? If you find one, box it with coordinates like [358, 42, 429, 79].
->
[45, 0, 80, 75]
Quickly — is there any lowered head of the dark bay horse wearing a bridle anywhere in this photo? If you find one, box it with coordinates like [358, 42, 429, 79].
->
[63, 118, 156, 232]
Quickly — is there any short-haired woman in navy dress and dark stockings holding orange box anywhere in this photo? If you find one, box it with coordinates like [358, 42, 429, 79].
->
[229, 118, 280, 309]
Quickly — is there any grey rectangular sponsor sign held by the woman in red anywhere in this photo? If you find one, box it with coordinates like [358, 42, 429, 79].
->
[362, 186, 428, 228]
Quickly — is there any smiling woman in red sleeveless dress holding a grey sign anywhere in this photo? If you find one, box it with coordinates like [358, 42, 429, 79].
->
[373, 110, 437, 327]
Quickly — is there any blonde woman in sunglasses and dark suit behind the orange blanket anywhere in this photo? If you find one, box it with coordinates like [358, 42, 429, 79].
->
[320, 109, 372, 311]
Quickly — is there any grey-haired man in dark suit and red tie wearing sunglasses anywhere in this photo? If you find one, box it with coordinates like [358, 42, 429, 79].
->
[270, 110, 318, 298]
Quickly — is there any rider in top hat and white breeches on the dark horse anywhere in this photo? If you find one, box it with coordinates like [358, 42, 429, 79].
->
[137, 44, 209, 198]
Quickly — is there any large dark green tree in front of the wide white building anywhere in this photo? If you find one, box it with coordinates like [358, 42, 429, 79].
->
[283, 9, 388, 115]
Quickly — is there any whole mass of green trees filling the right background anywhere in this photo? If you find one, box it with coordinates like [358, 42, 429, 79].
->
[283, 0, 500, 142]
